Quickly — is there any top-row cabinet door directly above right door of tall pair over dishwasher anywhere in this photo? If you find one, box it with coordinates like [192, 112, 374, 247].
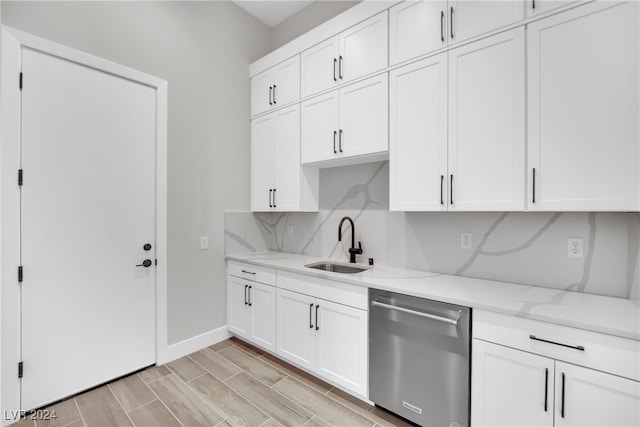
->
[447, 0, 524, 43]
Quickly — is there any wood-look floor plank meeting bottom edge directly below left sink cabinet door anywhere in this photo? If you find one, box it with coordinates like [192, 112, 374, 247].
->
[225, 372, 313, 426]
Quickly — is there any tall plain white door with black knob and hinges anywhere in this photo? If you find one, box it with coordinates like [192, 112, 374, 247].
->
[21, 48, 156, 410]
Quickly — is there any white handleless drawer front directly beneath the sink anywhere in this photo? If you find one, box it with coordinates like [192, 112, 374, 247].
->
[278, 271, 368, 310]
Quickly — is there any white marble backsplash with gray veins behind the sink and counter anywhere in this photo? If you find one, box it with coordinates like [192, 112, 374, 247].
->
[225, 162, 640, 300]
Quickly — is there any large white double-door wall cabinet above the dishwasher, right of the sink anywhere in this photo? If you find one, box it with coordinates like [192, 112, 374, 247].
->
[390, 28, 525, 211]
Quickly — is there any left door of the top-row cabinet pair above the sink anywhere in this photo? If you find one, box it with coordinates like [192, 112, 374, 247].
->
[300, 36, 340, 97]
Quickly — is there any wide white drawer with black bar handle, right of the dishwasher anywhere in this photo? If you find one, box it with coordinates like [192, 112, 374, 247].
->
[472, 310, 640, 381]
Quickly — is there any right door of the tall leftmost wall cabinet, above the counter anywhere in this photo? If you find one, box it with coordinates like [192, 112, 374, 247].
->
[273, 104, 301, 211]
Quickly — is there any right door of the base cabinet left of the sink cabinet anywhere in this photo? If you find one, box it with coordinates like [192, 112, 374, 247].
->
[249, 282, 276, 351]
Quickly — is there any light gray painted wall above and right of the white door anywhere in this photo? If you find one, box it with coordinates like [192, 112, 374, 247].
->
[1, 1, 271, 343]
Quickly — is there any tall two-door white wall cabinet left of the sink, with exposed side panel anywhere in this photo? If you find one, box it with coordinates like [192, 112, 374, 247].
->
[251, 104, 318, 212]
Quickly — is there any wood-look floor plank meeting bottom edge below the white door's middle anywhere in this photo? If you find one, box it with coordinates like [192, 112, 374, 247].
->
[76, 386, 132, 427]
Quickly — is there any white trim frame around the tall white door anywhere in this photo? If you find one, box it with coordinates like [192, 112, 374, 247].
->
[0, 26, 171, 426]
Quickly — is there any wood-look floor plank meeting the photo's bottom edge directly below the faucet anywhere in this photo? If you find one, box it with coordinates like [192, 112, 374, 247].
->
[273, 377, 374, 426]
